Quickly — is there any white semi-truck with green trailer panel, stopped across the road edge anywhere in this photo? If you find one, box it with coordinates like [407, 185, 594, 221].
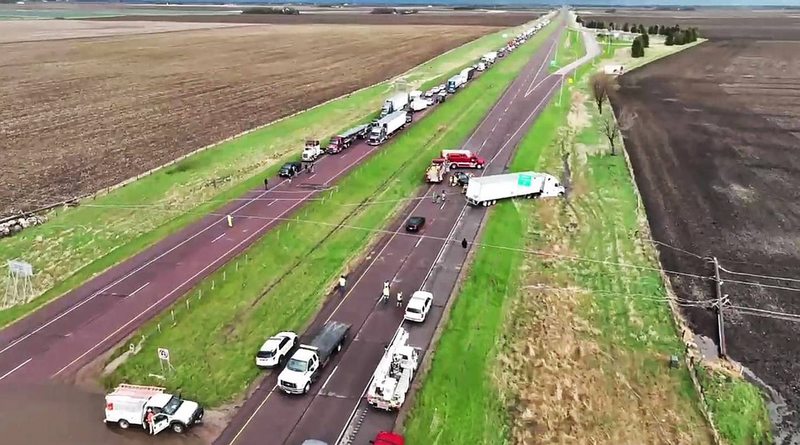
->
[466, 172, 564, 207]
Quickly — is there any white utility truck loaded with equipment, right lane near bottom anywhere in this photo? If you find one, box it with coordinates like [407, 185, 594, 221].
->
[367, 328, 419, 411]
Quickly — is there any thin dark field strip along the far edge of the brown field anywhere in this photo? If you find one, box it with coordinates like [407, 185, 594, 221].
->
[92, 11, 540, 27]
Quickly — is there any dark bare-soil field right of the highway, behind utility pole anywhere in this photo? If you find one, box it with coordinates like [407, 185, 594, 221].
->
[615, 9, 800, 444]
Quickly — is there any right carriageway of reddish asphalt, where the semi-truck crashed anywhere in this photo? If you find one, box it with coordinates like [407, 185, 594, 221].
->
[215, 13, 580, 445]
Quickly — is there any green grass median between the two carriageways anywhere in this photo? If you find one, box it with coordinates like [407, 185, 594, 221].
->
[106, 23, 547, 406]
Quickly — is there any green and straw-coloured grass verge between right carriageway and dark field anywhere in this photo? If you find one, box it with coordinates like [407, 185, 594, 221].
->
[405, 32, 711, 444]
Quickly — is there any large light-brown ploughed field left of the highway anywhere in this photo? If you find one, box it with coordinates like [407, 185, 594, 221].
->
[0, 22, 496, 215]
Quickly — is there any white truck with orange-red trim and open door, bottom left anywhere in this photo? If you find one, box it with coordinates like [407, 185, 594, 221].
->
[103, 384, 204, 434]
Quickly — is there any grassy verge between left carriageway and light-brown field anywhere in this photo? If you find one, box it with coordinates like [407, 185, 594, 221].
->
[0, 18, 544, 327]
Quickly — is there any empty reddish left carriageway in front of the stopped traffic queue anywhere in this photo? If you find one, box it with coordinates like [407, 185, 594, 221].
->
[0, 80, 450, 386]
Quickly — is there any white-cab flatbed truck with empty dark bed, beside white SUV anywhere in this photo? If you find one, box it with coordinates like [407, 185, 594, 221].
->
[278, 321, 350, 394]
